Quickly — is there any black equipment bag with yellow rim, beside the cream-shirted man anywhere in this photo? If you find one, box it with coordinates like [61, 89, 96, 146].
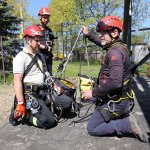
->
[46, 77, 76, 120]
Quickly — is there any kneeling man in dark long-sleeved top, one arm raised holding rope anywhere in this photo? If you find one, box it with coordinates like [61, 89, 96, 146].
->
[81, 16, 146, 142]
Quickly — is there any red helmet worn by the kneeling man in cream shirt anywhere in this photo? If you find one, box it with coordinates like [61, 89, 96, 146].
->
[23, 25, 43, 37]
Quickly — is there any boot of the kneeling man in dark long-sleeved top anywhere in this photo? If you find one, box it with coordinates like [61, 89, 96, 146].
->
[129, 114, 147, 143]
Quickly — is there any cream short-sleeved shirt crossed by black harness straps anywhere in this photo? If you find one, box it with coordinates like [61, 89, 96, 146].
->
[13, 48, 44, 86]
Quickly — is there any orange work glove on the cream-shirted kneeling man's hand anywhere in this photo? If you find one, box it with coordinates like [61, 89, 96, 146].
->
[14, 101, 25, 119]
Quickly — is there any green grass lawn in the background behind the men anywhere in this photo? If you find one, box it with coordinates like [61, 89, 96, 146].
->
[0, 61, 149, 85]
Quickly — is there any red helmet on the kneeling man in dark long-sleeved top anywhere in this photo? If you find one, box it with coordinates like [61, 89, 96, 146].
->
[96, 16, 123, 32]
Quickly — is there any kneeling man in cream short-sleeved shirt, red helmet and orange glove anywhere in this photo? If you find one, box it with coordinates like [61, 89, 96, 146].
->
[9, 25, 56, 128]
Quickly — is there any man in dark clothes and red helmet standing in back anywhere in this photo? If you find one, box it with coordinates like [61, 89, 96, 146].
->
[37, 7, 55, 74]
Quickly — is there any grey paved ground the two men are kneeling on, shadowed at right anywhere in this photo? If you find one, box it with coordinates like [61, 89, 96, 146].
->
[0, 78, 150, 150]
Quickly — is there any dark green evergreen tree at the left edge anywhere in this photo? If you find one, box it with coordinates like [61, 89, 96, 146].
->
[0, 0, 23, 69]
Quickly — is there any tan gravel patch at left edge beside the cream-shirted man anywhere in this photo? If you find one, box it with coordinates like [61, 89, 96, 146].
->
[0, 85, 14, 126]
